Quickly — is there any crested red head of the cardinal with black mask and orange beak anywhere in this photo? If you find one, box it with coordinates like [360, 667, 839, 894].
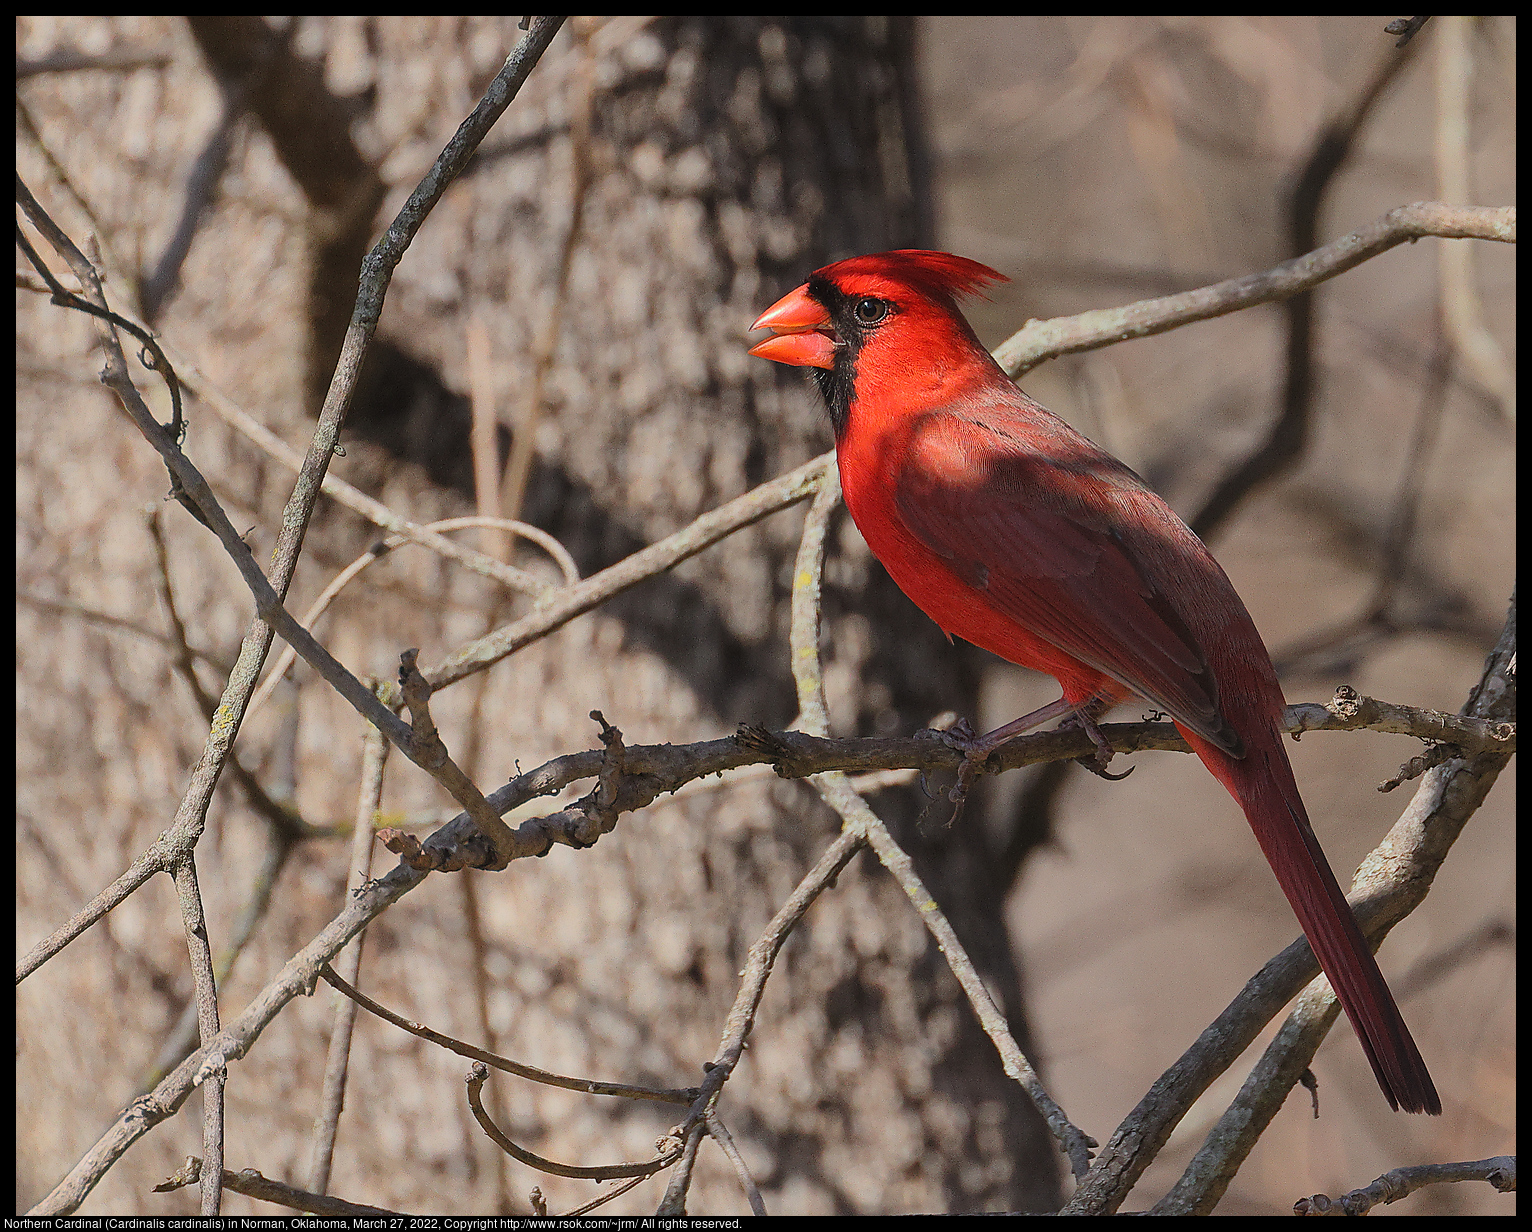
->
[751, 248, 1005, 437]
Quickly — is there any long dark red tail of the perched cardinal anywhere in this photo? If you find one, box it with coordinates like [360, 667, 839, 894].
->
[1183, 731, 1442, 1116]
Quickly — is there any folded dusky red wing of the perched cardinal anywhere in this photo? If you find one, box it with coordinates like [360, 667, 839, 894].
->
[892, 417, 1244, 757]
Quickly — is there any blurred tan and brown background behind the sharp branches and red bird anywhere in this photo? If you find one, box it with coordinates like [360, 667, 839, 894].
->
[17, 17, 1515, 1214]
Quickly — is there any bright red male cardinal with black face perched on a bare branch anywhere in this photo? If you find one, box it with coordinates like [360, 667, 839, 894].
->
[751, 250, 1442, 1114]
